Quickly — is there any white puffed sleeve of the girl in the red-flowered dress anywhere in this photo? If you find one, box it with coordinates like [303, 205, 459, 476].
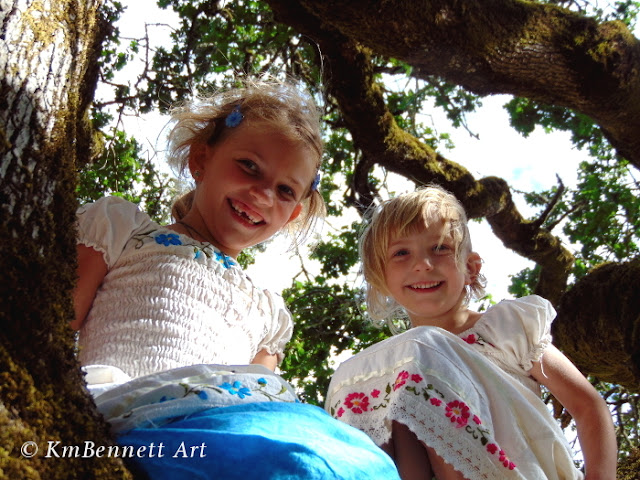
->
[479, 295, 556, 374]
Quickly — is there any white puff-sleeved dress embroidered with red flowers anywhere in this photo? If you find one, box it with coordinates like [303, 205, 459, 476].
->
[325, 296, 583, 479]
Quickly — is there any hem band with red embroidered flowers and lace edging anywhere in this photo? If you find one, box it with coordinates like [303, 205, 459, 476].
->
[330, 366, 522, 479]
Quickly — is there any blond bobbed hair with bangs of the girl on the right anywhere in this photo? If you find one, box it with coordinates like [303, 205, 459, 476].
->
[359, 185, 484, 331]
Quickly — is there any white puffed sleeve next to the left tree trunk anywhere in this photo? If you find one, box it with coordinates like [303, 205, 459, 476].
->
[77, 197, 151, 269]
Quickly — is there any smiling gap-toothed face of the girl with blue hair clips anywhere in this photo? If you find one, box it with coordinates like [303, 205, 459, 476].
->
[182, 121, 316, 258]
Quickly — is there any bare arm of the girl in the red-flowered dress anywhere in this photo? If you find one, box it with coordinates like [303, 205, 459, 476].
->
[529, 345, 618, 480]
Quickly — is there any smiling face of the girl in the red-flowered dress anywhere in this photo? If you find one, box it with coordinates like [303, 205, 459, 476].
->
[384, 222, 477, 328]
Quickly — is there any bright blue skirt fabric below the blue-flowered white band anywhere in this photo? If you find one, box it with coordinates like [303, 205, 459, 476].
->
[118, 402, 399, 480]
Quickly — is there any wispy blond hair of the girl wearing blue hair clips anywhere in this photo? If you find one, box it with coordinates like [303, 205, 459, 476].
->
[168, 80, 326, 246]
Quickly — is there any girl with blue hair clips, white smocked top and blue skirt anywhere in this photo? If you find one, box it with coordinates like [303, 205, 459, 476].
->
[72, 82, 398, 480]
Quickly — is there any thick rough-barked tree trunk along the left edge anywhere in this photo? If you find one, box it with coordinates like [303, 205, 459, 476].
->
[0, 0, 128, 479]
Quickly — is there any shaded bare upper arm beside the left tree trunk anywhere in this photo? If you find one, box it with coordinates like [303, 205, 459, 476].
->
[70, 244, 107, 330]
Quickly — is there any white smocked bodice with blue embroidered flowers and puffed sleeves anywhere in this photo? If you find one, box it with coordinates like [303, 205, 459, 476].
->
[78, 197, 292, 378]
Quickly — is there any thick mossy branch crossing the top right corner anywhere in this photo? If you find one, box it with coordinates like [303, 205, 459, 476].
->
[292, 0, 640, 168]
